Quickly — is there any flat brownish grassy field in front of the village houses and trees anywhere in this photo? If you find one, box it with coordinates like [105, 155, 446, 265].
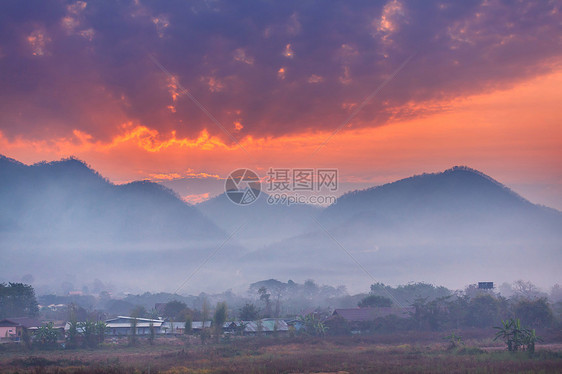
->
[0, 336, 562, 373]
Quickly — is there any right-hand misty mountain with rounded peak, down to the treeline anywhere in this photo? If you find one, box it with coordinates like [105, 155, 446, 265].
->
[245, 167, 562, 286]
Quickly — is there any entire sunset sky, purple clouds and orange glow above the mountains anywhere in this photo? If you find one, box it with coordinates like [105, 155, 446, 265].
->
[0, 0, 562, 209]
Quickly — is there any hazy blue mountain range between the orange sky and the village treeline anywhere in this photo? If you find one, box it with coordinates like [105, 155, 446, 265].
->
[0, 157, 562, 293]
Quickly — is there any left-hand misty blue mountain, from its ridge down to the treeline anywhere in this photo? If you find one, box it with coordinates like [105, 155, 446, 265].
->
[0, 157, 244, 292]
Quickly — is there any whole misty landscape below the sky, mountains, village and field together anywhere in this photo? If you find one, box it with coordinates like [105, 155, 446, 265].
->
[0, 153, 562, 373]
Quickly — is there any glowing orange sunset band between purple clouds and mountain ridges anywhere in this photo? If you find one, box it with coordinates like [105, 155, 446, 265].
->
[0, 67, 562, 207]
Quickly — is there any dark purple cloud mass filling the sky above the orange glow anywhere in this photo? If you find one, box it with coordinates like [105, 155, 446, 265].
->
[0, 0, 562, 140]
